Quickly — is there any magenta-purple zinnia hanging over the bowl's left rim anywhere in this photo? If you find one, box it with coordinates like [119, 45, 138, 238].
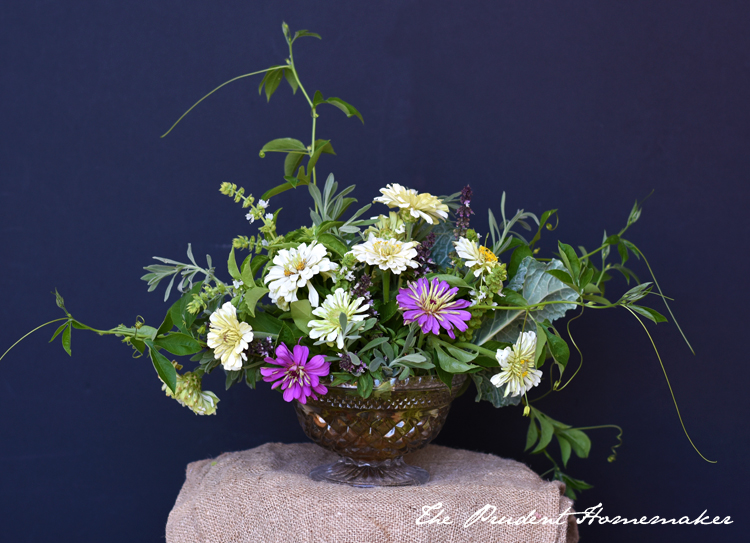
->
[260, 343, 331, 403]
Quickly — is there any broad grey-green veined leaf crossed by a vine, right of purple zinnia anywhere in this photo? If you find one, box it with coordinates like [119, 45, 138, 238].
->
[473, 257, 578, 346]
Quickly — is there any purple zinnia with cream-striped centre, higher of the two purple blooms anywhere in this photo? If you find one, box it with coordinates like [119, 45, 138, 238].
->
[396, 277, 471, 339]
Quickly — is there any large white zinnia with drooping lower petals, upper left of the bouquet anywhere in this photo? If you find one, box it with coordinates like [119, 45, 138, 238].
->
[263, 241, 338, 311]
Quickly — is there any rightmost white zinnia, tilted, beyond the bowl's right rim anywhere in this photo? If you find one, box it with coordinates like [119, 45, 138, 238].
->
[490, 332, 542, 396]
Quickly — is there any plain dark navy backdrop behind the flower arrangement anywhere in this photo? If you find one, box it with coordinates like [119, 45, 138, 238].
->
[0, 0, 750, 542]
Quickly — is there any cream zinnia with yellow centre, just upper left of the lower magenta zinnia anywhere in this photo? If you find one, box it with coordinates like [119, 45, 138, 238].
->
[206, 302, 253, 371]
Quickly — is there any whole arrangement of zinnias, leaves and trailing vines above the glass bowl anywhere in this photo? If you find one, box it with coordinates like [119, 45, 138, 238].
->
[3, 24, 712, 497]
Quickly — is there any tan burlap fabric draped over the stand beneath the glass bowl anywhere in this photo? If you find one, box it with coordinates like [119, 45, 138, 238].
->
[167, 443, 578, 543]
